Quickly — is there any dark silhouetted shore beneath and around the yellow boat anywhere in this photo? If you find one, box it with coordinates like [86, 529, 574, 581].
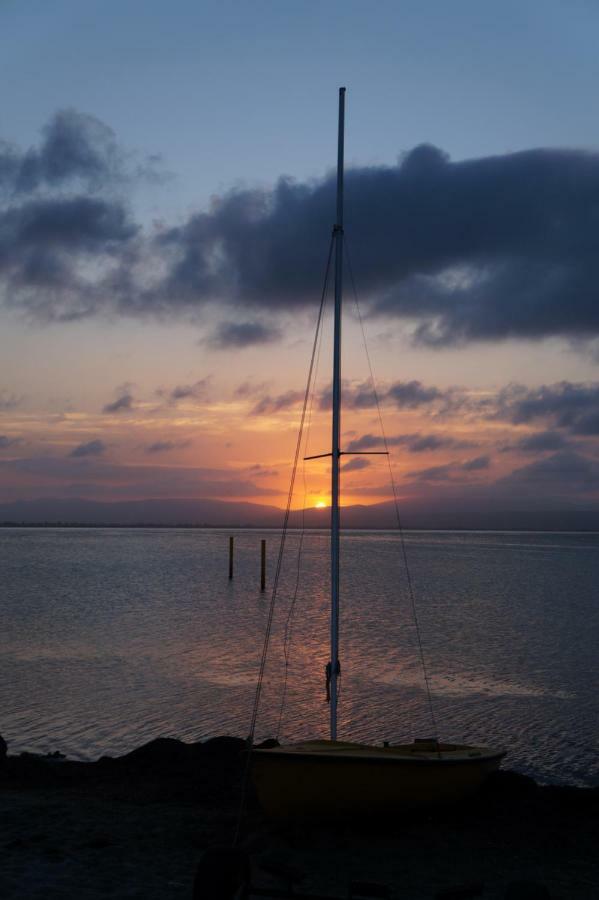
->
[0, 737, 599, 900]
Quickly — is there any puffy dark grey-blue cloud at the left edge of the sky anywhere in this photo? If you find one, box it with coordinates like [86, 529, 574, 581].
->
[0, 110, 159, 321]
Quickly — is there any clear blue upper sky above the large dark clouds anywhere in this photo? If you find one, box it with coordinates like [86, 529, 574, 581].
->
[0, 0, 599, 209]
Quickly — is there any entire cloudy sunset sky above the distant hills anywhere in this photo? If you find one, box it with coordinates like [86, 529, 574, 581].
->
[0, 0, 599, 508]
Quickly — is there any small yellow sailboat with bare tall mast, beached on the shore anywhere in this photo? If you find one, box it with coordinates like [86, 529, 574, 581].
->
[250, 88, 505, 819]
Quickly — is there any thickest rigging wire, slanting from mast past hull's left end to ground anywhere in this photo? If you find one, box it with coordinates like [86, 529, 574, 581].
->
[233, 232, 335, 846]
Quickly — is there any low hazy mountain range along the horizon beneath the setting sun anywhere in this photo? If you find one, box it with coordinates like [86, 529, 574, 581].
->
[0, 499, 599, 531]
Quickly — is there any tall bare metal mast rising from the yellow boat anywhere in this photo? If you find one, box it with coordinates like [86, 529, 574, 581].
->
[329, 88, 345, 741]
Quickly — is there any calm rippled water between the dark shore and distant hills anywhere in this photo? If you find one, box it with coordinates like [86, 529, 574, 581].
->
[0, 529, 599, 785]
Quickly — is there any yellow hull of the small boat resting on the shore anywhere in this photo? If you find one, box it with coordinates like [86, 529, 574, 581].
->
[251, 741, 505, 819]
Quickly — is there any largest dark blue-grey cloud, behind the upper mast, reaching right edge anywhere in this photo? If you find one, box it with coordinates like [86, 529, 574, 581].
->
[143, 146, 599, 343]
